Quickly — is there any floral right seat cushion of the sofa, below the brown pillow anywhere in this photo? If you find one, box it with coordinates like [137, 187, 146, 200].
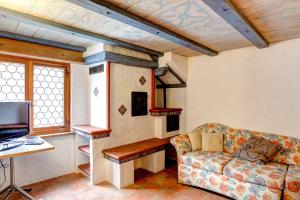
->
[223, 158, 287, 190]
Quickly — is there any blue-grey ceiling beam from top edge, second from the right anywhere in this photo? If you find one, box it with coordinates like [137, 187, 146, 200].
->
[67, 0, 218, 56]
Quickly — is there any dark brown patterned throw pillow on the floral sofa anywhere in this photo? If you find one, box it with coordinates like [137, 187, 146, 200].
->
[234, 137, 280, 164]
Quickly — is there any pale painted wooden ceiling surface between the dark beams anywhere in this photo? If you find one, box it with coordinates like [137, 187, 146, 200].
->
[0, 0, 300, 56]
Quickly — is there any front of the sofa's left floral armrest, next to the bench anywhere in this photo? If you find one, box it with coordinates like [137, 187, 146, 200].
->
[170, 135, 192, 163]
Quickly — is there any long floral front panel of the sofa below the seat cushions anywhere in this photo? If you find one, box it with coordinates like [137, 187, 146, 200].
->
[178, 164, 282, 200]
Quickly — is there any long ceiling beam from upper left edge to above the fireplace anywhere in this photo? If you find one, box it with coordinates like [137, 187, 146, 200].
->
[0, 6, 164, 57]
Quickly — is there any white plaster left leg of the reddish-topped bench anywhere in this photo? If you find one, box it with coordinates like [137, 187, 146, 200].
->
[106, 160, 134, 189]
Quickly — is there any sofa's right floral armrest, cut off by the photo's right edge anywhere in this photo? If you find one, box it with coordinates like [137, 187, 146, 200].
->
[284, 165, 300, 200]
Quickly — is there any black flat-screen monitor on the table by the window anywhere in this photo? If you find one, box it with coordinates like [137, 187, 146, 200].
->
[0, 102, 30, 142]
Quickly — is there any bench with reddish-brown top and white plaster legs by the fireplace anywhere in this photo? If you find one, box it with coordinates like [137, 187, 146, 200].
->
[102, 138, 170, 188]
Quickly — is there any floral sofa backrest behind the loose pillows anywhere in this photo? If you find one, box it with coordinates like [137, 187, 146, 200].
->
[195, 123, 300, 166]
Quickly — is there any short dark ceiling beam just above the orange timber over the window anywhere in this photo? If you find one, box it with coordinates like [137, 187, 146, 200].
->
[0, 31, 86, 52]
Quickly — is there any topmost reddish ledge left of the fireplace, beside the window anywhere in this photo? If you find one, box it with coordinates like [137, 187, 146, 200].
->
[73, 125, 111, 139]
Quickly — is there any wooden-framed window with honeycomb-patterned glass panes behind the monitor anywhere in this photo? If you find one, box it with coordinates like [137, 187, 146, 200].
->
[0, 55, 70, 135]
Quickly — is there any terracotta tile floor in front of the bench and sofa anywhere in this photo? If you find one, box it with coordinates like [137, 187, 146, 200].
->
[4, 165, 227, 200]
